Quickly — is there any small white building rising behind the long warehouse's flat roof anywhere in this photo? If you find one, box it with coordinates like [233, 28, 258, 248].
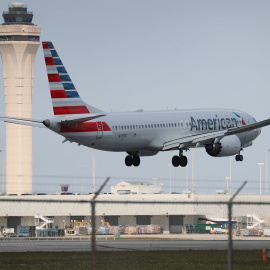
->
[111, 181, 164, 194]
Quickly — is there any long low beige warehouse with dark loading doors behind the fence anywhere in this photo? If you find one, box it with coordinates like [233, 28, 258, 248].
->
[0, 194, 270, 233]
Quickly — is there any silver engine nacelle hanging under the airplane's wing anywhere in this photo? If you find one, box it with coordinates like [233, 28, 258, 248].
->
[205, 135, 242, 157]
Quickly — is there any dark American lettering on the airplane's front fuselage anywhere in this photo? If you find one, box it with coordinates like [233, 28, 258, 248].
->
[190, 117, 238, 131]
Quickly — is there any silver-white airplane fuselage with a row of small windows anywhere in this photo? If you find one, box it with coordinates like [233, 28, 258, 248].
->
[49, 109, 260, 155]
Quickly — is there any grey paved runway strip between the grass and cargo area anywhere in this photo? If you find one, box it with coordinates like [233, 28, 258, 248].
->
[0, 239, 270, 252]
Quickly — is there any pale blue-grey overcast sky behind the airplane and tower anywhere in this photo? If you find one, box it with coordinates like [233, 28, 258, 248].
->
[0, 0, 270, 194]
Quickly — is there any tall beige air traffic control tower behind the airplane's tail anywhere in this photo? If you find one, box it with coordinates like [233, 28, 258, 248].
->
[0, 3, 41, 194]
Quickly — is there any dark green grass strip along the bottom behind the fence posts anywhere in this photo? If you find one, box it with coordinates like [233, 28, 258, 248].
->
[0, 250, 270, 270]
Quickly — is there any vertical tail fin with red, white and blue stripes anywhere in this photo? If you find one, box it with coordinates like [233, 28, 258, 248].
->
[42, 41, 102, 116]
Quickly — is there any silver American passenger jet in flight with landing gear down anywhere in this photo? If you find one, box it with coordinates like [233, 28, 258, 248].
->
[1, 41, 270, 167]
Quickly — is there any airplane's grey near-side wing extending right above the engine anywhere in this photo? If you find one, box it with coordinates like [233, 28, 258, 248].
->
[162, 118, 270, 151]
